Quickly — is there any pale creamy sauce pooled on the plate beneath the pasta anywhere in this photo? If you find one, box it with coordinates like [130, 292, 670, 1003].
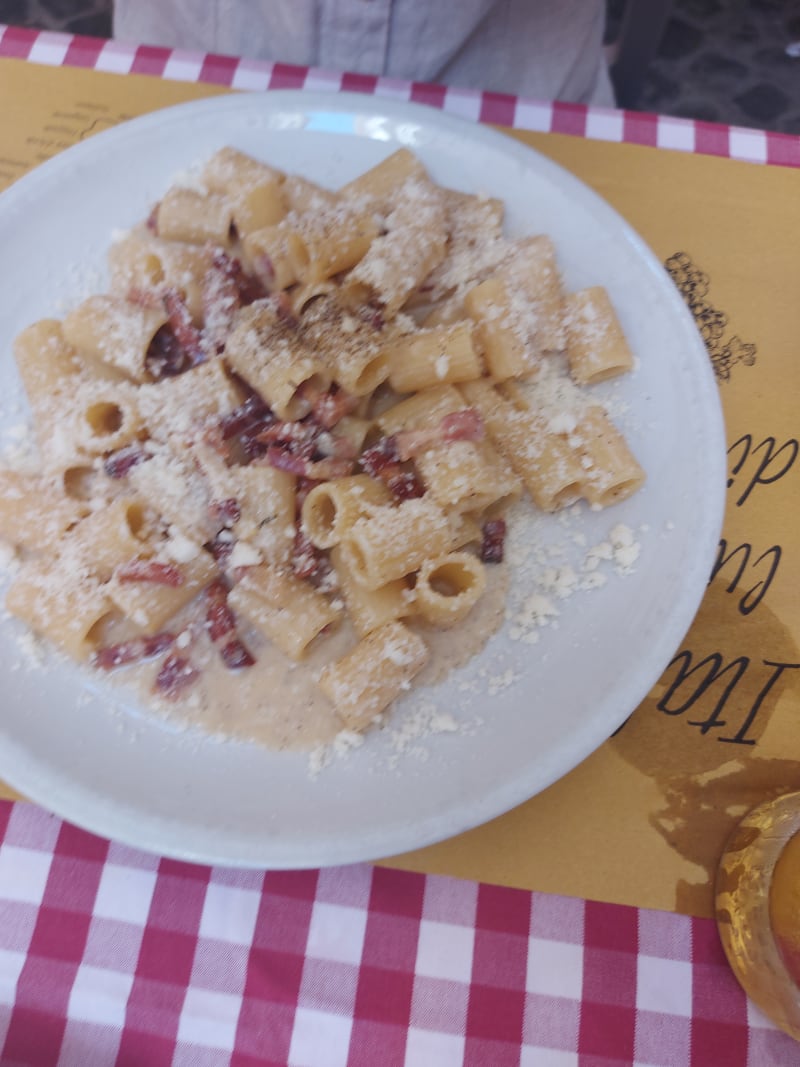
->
[111, 564, 509, 750]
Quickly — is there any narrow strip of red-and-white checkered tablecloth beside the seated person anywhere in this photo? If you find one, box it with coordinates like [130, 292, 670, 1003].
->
[0, 25, 800, 166]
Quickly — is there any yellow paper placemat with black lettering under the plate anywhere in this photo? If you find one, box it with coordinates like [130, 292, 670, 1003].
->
[0, 60, 800, 914]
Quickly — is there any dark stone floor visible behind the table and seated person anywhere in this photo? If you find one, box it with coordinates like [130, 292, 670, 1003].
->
[0, 0, 800, 133]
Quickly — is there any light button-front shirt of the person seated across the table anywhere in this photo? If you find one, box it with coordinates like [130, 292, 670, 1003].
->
[114, 0, 613, 106]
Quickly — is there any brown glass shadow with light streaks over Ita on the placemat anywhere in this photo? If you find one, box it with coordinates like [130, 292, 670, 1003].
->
[609, 577, 800, 914]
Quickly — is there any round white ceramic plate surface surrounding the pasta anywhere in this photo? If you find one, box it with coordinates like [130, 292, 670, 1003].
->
[0, 92, 724, 867]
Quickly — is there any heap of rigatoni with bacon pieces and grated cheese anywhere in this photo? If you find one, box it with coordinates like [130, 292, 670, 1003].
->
[0, 146, 644, 740]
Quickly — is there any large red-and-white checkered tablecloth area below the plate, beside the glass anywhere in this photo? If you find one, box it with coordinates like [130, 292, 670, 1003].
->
[0, 801, 800, 1067]
